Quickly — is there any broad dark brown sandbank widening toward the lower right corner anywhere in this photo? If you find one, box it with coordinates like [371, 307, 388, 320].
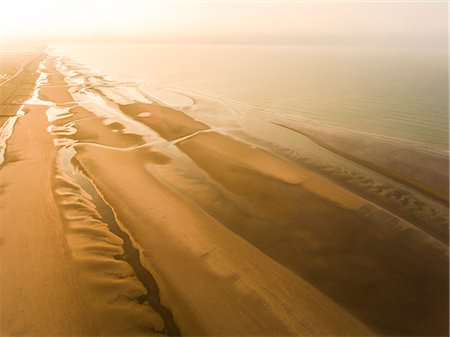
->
[76, 65, 448, 334]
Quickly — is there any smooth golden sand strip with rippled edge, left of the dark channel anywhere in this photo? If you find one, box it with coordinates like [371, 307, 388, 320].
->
[0, 56, 163, 336]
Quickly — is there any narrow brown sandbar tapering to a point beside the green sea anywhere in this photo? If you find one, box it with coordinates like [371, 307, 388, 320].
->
[272, 123, 449, 204]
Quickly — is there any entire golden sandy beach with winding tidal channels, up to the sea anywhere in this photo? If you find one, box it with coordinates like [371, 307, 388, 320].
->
[0, 54, 449, 336]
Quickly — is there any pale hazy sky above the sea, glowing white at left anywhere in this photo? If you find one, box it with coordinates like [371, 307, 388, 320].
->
[0, 0, 447, 43]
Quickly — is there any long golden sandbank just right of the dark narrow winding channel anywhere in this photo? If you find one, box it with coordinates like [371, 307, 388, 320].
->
[74, 144, 371, 336]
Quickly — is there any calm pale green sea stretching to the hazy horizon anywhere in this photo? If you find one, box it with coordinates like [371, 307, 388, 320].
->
[50, 43, 449, 151]
